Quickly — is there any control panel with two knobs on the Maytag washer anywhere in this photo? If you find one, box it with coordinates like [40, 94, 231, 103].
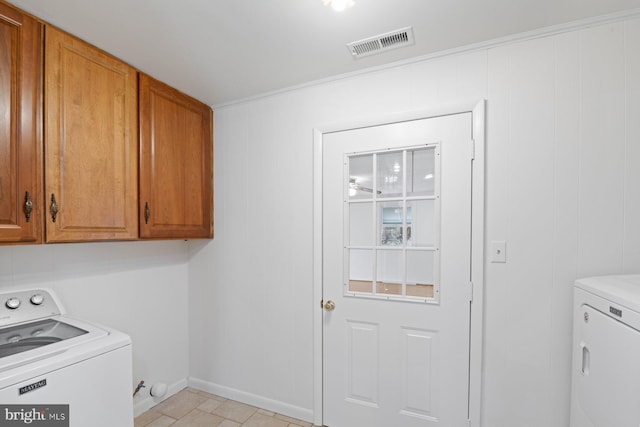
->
[0, 289, 61, 327]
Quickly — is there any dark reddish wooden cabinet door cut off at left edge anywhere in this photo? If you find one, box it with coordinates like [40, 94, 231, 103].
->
[0, 3, 43, 243]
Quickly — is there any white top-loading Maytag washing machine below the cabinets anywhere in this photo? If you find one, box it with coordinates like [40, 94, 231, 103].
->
[0, 289, 133, 427]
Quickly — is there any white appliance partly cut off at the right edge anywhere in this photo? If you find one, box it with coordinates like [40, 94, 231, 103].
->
[571, 275, 640, 427]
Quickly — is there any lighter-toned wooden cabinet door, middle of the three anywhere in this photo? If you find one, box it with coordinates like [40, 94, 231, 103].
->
[45, 27, 138, 242]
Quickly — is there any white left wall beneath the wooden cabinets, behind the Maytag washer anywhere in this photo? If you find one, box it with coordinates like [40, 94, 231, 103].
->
[0, 241, 189, 410]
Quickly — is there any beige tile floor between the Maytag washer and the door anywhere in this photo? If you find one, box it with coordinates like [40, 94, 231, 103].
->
[135, 388, 311, 427]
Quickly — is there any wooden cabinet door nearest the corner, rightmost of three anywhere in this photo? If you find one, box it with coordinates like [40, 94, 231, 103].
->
[140, 74, 213, 239]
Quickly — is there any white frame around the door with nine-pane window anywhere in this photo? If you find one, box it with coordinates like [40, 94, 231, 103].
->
[313, 99, 486, 426]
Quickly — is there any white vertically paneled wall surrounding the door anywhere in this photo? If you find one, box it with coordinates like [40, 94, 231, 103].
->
[189, 15, 640, 427]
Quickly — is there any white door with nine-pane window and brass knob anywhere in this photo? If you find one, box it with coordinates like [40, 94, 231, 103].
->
[322, 113, 473, 427]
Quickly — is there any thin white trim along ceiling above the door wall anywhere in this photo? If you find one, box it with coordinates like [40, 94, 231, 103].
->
[213, 8, 640, 110]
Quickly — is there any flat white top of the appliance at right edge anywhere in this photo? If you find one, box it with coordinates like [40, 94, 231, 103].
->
[575, 274, 640, 312]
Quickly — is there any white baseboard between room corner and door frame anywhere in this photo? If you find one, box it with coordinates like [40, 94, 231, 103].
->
[187, 377, 313, 424]
